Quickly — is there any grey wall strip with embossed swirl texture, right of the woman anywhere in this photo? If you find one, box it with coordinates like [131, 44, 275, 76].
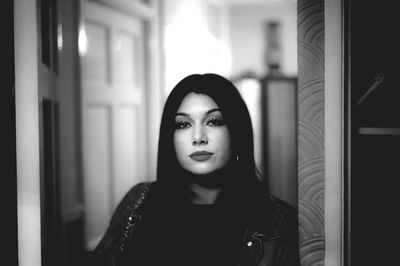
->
[298, 0, 324, 266]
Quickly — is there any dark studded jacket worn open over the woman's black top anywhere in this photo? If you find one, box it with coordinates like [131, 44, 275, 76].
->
[90, 183, 300, 266]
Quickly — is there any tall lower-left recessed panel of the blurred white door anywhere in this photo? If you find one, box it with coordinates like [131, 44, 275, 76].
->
[84, 105, 112, 246]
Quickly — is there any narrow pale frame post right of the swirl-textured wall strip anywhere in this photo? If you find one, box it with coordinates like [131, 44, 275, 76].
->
[324, 0, 347, 266]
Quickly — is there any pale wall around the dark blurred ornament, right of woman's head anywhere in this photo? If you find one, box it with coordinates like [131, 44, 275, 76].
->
[229, 1, 297, 76]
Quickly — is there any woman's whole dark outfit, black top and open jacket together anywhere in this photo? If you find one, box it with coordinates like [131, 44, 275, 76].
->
[92, 183, 300, 266]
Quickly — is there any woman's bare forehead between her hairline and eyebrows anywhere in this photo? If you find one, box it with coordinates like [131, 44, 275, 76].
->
[178, 92, 218, 113]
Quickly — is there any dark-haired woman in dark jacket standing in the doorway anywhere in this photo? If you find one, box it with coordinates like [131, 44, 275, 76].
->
[90, 74, 299, 266]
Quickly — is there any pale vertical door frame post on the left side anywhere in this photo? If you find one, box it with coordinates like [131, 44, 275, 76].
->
[14, 0, 41, 266]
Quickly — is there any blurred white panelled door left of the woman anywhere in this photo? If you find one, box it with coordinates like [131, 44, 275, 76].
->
[80, 1, 148, 249]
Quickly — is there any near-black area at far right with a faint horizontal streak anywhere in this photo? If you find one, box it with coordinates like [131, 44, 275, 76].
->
[346, 0, 400, 266]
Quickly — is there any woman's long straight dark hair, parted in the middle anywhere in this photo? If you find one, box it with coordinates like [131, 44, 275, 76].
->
[157, 73, 266, 208]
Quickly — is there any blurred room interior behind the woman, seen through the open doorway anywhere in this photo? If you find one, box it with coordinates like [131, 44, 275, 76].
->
[24, 0, 298, 265]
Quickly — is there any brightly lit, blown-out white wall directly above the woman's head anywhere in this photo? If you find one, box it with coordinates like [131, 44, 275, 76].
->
[162, 0, 231, 96]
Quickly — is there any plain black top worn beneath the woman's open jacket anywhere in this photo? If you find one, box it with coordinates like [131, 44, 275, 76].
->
[121, 200, 244, 266]
